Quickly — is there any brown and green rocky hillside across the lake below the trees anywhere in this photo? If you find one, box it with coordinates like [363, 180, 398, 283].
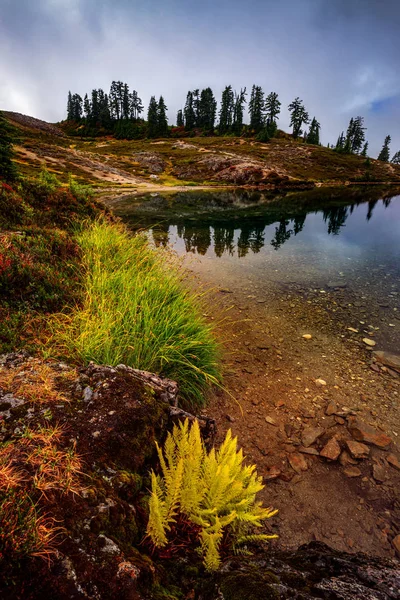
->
[5, 113, 400, 189]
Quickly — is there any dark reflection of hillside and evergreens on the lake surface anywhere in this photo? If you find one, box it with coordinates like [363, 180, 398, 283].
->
[113, 188, 398, 258]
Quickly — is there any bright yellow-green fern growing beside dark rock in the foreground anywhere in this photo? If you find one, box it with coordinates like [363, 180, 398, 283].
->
[147, 419, 277, 571]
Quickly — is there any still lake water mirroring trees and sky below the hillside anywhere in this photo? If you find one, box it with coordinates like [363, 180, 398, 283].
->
[112, 188, 400, 353]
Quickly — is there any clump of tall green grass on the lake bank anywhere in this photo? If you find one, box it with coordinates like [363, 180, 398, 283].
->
[51, 221, 221, 405]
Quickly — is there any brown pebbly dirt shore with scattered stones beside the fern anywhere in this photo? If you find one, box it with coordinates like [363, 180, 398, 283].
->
[186, 252, 400, 556]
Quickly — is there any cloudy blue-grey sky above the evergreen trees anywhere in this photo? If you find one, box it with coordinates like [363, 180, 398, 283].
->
[0, 0, 400, 157]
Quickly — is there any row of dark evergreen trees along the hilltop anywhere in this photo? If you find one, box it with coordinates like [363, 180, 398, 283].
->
[67, 81, 400, 164]
